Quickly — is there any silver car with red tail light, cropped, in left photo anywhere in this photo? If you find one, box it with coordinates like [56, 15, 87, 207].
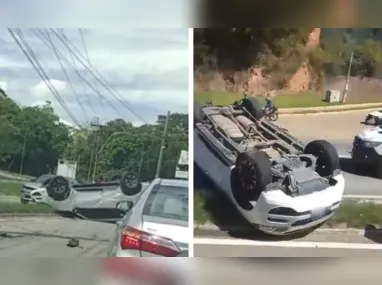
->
[107, 178, 190, 257]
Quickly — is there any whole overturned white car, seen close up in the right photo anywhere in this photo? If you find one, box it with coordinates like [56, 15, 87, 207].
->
[194, 98, 345, 235]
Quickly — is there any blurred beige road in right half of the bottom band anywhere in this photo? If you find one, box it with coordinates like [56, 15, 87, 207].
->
[197, 258, 382, 285]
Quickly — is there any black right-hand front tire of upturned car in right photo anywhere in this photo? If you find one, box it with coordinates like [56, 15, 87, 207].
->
[304, 140, 340, 177]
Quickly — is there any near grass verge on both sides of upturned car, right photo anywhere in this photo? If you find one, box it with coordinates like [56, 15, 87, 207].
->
[194, 191, 382, 229]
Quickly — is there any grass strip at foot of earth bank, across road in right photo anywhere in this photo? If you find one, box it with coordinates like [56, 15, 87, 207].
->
[195, 91, 374, 109]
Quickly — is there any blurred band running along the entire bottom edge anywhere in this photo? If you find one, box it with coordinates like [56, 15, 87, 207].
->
[0, 258, 382, 285]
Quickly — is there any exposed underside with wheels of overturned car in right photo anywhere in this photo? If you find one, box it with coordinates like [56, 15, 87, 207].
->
[195, 99, 339, 200]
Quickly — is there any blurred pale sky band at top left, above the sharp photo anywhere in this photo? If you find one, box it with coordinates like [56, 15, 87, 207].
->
[0, 0, 191, 27]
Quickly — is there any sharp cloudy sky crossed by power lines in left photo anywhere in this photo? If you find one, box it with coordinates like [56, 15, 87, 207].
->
[0, 28, 188, 124]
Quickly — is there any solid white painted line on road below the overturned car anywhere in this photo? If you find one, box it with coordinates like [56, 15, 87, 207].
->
[193, 238, 382, 250]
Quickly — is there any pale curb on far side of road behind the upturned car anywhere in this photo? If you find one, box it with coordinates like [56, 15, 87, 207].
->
[278, 103, 382, 115]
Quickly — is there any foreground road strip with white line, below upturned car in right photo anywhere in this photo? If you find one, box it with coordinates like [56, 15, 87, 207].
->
[194, 229, 382, 258]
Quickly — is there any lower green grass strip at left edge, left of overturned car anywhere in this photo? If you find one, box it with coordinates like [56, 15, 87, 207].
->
[0, 202, 54, 215]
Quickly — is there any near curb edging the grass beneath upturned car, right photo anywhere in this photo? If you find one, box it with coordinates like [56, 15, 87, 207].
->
[194, 224, 372, 235]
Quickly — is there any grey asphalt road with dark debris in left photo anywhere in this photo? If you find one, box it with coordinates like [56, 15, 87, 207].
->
[0, 217, 115, 257]
